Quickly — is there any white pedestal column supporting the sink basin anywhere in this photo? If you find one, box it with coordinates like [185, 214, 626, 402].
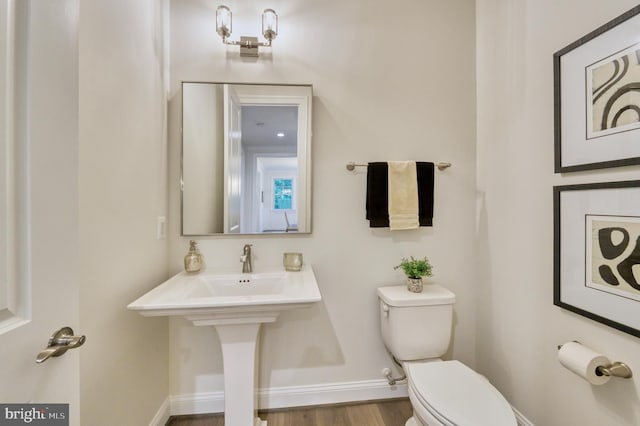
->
[215, 323, 267, 426]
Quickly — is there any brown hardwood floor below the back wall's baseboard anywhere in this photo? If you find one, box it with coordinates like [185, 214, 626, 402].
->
[166, 399, 413, 426]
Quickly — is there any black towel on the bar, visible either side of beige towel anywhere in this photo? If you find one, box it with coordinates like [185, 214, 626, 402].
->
[366, 162, 434, 228]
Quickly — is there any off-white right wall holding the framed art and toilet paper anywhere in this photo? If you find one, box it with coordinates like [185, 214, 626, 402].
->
[474, 0, 640, 426]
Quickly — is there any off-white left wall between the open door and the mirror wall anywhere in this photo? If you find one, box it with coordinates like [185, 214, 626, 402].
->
[79, 0, 168, 426]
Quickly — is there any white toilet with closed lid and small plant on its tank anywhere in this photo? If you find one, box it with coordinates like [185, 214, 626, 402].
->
[378, 284, 518, 426]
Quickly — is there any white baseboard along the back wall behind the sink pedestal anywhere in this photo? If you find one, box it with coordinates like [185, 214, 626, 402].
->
[169, 379, 408, 416]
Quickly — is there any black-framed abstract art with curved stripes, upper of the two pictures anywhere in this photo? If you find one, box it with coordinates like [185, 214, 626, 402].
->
[553, 6, 640, 173]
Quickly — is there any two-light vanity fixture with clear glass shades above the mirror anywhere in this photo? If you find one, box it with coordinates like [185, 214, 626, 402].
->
[216, 6, 278, 57]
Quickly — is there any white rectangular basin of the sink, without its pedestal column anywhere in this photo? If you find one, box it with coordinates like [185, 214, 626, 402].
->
[127, 265, 321, 317]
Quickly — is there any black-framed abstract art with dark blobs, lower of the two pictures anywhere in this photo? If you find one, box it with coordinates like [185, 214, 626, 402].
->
[553, 181, 640, 337]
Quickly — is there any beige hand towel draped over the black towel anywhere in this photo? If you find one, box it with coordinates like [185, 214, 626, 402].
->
[388, 161, 420, 231]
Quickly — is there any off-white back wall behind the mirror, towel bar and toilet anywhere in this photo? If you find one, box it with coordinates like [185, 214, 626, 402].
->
[169, 0, 481, 406]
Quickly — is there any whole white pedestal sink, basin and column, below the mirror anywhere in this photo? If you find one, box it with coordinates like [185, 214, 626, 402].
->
[127, 265, 321, 426]
